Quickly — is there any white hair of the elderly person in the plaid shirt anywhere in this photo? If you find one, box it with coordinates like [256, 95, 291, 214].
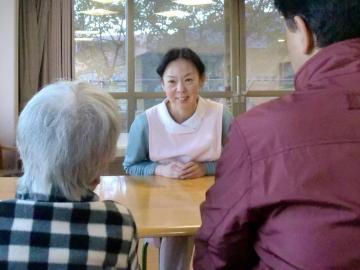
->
[17, 81, 120, 201]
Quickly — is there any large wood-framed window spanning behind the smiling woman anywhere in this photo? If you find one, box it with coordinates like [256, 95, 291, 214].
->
[74, 0, 292, 132]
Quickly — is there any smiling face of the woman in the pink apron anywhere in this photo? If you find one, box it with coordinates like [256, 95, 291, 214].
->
[162, 58, 204, 113]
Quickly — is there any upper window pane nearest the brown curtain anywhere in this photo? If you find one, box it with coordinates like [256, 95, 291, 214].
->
[74, 0, 127, 92]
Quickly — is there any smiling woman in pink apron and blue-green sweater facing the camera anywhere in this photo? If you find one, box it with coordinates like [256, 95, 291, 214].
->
[124, 48, 232, 270]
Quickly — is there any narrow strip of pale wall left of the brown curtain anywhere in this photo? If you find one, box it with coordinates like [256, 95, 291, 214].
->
[0, 0, 18, 145]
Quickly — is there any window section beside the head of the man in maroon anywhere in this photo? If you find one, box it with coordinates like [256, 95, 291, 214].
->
[244, 0, 293, 110]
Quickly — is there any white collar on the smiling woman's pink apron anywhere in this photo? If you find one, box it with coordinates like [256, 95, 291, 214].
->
[159, 96, 206, 134]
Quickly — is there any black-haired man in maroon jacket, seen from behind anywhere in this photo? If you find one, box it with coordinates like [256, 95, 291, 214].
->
[194, 0, 360, 270]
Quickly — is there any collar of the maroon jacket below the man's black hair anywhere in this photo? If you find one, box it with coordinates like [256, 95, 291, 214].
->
[295, 38, 360, 91]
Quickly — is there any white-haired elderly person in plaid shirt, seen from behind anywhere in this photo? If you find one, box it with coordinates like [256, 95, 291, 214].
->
[0, 81, 139, 269]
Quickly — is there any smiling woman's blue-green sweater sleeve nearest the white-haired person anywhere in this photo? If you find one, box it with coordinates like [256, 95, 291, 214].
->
[123, 112, 156, 175]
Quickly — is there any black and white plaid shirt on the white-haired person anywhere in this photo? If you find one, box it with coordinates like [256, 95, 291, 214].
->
[0, 200, 139, 270]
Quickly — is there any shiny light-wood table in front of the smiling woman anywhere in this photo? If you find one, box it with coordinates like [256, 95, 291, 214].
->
[0, 176, 214, 237]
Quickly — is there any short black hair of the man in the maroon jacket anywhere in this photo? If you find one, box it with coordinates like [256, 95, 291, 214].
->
[274, 0, 360, 48]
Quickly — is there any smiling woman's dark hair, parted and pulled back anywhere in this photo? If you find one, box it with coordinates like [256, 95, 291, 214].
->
[156, 48, 205, 78]
